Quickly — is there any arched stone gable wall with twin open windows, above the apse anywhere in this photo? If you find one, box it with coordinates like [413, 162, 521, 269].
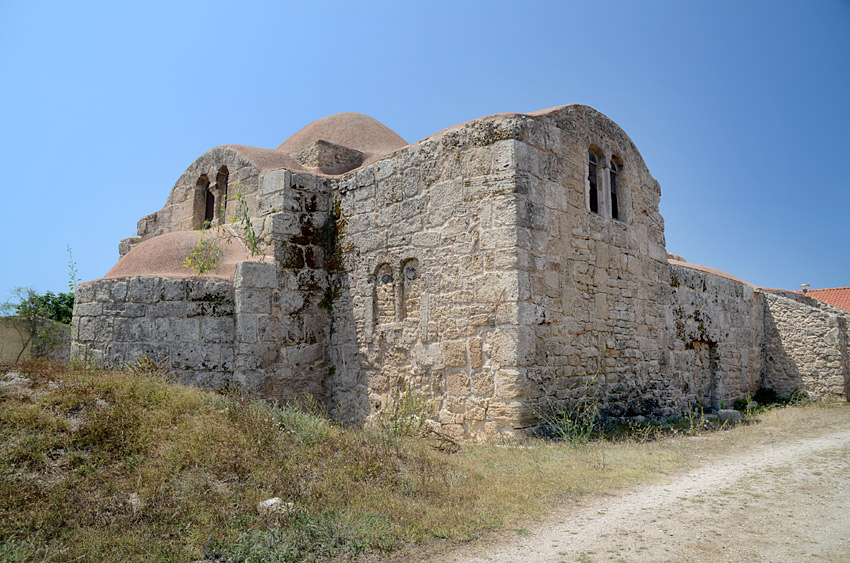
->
[134, 147, 260, 245]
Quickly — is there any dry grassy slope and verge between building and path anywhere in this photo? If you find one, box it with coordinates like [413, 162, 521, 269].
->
[0, 363, 850, 561]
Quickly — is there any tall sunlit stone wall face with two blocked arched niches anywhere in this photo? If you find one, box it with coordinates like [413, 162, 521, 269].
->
[328, 115, 528, 438]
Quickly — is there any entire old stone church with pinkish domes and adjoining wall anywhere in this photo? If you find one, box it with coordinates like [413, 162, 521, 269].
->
[72, 105, 850, 439]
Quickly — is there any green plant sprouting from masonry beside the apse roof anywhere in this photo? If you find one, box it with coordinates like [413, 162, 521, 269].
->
[183, 184, 260, 275]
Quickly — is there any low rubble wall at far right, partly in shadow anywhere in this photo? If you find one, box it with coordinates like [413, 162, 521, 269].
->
[762, 292, 850, 399]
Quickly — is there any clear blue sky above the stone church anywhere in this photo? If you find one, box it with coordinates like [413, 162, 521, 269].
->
[0, 0, 850, 300]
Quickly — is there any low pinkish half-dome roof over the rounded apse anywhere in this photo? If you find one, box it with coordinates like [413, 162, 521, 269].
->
[103, 231, 262, 280]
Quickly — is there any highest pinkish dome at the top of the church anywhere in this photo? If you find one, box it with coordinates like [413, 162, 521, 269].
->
[275, 111, 408, 164]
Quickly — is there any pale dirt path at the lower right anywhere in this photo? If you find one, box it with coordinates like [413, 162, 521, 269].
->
[434, 430, 850, 562]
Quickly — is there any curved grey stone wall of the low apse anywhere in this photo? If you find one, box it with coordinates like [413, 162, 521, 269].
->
[71, 277, 234, 388]
